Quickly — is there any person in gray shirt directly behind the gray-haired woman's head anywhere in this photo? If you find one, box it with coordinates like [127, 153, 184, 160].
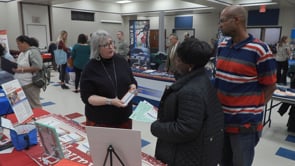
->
[116, 31, 129, 61]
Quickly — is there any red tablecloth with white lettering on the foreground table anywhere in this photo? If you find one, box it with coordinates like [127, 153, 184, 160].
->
[0, 109, 165, 166]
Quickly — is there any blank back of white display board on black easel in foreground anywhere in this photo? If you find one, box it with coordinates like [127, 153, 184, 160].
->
[86, 126, 142, 166]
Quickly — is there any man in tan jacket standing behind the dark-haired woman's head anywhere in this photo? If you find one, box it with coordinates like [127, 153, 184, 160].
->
[166, 34, 179, 74]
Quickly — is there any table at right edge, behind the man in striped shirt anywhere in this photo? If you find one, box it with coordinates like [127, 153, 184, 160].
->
[263, 88, 295, 127]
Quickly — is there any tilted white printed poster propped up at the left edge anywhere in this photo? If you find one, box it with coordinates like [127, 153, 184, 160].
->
[1, 80, 33, 124]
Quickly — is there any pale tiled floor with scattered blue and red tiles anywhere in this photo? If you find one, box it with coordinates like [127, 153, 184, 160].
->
[41, 72, 295, 166]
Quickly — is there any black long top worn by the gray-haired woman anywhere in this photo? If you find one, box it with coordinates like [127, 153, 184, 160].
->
[80, 55, 137, 124]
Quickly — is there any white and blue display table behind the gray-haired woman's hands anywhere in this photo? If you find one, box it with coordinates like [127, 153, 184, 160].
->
[132, 69, 175, 107]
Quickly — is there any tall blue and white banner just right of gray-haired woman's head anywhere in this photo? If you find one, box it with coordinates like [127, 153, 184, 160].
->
[129, 20, 150, 67]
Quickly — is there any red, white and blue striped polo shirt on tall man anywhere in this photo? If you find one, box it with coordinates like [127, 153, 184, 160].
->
[215, 34, 276, 124]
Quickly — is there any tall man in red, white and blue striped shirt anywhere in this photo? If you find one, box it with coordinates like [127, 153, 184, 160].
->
[215, 5, 276, 166]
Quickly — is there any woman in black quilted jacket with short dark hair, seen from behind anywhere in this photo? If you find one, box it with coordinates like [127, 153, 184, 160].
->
[151, 39, 224, 166]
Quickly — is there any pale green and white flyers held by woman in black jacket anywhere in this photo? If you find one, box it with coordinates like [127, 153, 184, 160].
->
[129, 100, 158, 122]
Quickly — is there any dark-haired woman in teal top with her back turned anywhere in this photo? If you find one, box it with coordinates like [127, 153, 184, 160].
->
[71, 34, 90, 93]
